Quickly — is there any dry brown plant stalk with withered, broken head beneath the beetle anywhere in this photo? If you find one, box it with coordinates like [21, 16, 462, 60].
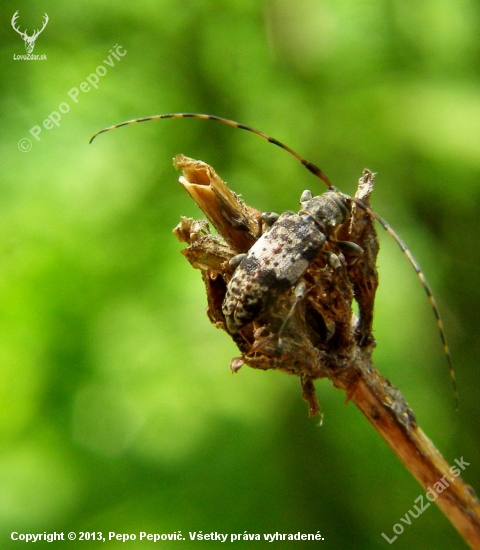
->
[174, 155, 480, 549]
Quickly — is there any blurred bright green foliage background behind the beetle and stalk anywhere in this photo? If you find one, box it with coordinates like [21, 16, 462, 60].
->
[0, 0, 480, 549]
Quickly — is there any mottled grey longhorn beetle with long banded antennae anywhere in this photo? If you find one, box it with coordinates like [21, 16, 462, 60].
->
[89, 113, 458, 409]
